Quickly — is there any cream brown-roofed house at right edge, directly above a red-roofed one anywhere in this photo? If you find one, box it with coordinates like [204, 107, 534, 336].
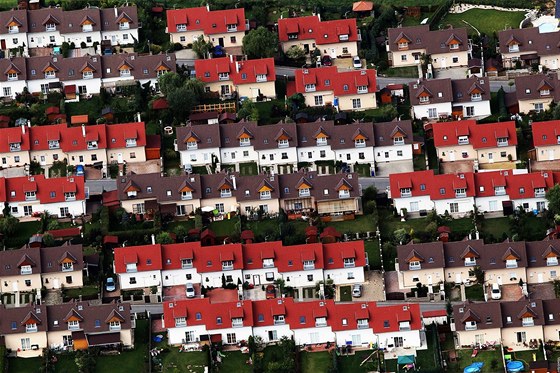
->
[515, 74, 560, 113]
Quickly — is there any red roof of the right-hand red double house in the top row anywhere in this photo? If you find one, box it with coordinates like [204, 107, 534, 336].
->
[278, 16, 358, 45]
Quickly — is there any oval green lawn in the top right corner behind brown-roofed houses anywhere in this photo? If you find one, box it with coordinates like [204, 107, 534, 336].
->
[440, 9, 524, 35]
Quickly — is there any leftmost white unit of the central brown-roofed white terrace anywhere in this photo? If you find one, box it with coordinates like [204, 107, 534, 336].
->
[176, 125, 221, 167]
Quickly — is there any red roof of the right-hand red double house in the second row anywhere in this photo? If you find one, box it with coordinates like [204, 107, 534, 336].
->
[295, 66, 377, 96]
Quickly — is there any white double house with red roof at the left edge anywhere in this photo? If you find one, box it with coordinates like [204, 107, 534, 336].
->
[0, 175, 86, 218]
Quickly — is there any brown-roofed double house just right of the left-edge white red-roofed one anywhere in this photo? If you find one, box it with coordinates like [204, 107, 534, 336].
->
[117, 173, 202, 218]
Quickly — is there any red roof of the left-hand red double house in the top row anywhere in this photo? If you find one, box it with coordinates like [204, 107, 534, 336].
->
[167, 7, 246, 35]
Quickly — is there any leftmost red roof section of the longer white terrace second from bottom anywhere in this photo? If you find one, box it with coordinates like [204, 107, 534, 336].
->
[115, 244, 163, 273]
